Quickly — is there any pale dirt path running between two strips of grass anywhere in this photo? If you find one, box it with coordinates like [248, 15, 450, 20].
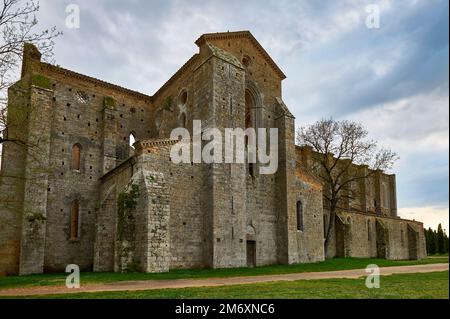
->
[0, 263, 449, 296]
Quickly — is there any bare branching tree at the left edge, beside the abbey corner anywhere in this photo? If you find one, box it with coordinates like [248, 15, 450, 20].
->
[0, 0, 62, 147]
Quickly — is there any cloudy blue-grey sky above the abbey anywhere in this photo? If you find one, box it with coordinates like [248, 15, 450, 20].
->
[32, 0, 449, 230]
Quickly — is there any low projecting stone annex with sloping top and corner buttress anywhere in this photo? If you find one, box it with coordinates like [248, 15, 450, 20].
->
[94, 142, 209, 271]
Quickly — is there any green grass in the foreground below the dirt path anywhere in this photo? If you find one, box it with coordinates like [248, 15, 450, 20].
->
[12, 271, 448, 299]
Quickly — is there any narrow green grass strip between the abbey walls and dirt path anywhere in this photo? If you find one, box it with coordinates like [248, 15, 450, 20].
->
[0, 257, 448, 289]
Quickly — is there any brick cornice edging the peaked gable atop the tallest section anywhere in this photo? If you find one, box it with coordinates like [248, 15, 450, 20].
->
[195, 31, 286, 80]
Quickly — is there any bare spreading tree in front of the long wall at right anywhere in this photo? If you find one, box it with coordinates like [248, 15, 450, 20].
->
[297, 119, 398, 256]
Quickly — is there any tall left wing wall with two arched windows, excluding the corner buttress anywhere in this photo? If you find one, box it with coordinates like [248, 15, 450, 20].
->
[37, 51, 156, 271]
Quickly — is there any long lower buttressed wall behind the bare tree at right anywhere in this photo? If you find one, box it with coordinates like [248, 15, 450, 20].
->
[297, 146, 426, 259]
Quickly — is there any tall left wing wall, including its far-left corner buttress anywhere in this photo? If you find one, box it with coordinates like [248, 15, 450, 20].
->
[0, 45, 158, 273]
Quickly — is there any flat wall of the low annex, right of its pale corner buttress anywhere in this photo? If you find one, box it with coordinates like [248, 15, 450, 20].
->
[140, 143, 211, 268]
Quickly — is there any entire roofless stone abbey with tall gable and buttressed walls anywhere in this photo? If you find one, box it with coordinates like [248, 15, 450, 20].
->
[0, 31, 426, 274]
